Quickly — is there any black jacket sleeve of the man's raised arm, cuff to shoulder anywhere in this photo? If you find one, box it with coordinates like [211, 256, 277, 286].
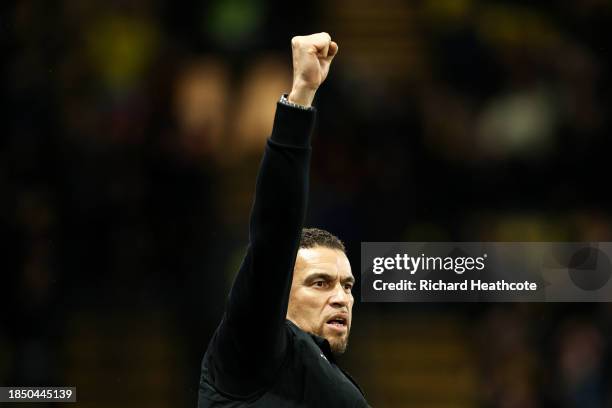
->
[207, 103, 316, 396]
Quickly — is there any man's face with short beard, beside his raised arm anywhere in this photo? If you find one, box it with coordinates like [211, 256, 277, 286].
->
[287, 246, 355, 354]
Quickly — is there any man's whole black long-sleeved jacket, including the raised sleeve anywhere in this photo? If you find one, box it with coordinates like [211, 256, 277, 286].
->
[198, 103, 367, 408]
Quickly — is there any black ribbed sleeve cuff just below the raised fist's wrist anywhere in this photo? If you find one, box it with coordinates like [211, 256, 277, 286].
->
[270, 97, 316, 148]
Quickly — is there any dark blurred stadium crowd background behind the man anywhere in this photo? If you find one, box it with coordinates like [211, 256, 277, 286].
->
[0, 0, 612, 408]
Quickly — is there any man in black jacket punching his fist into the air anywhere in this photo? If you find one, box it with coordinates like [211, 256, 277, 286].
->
[198, 33, 367, 408]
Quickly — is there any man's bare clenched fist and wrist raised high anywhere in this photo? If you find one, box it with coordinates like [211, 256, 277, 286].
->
[287, 33, 338, 106]
